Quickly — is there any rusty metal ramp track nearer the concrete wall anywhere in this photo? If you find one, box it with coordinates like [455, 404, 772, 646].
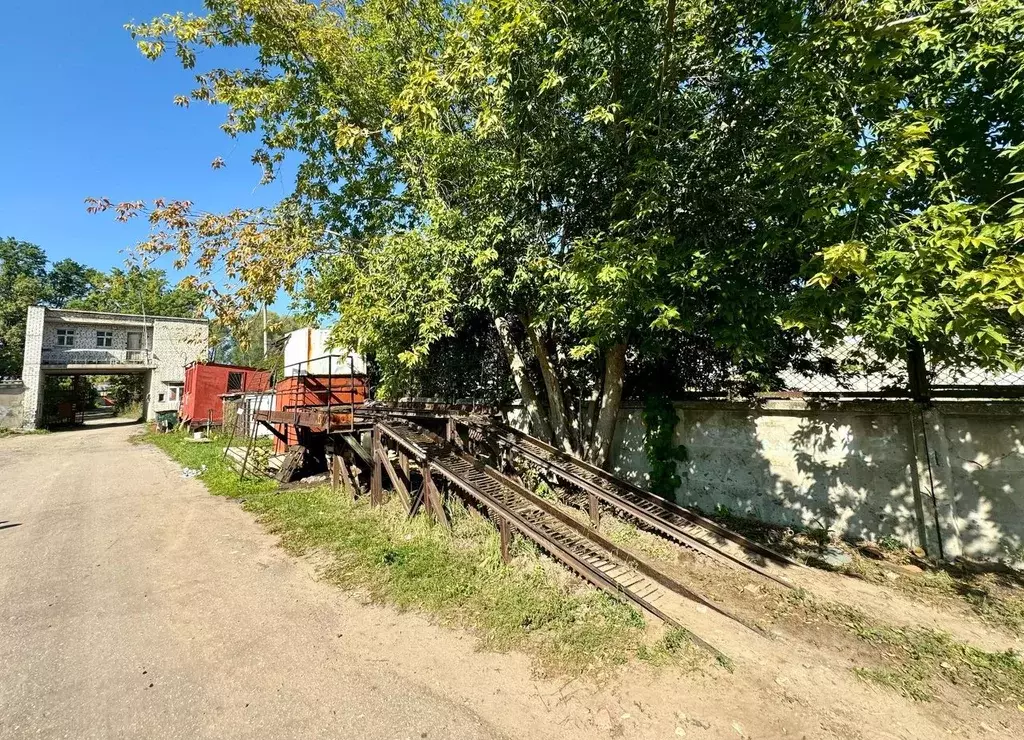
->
[469, 421, 804, 589]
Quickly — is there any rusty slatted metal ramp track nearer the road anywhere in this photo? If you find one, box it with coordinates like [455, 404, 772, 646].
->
[377, 420, 761, 660]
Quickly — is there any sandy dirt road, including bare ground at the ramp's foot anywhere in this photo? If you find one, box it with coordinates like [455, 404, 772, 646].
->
[0, 427, 1024, 740]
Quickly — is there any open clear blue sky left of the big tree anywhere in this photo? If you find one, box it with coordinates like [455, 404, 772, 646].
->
[0, 0, 291, 307]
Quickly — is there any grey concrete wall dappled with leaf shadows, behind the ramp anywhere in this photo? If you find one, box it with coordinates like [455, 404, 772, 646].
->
[614, 401, 1024, 560]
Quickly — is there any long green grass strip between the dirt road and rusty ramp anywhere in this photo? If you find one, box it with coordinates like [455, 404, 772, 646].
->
[142, 433, 703, 673]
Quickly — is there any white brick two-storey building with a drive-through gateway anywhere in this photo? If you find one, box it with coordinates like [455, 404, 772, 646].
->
[22, 306, 210, 429]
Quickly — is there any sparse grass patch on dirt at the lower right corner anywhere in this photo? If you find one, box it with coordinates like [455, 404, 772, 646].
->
[786, 591, 1024, 704]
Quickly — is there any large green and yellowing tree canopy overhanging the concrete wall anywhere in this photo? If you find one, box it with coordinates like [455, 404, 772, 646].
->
[90, 0, 1024, 462]
